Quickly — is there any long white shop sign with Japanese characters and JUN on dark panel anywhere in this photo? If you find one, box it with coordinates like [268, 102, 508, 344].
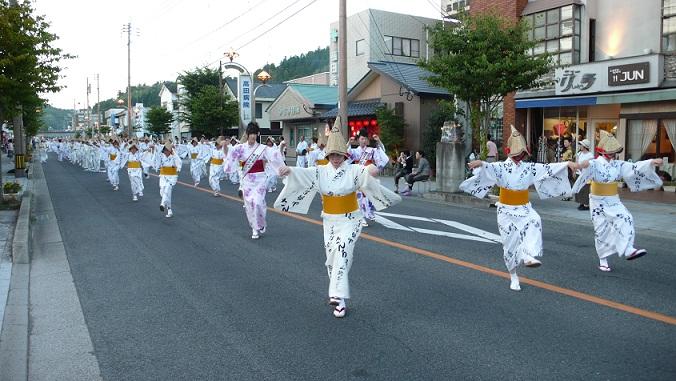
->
[554, 54, 663, 95]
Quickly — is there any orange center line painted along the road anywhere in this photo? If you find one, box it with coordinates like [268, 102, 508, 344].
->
[162, 175, 676, 325]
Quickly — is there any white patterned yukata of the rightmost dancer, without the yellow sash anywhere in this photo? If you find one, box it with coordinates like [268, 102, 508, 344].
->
[573, 157, 662, 259]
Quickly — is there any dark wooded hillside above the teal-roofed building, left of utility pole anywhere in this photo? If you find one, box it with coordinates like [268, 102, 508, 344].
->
[254, 46, 329, 83]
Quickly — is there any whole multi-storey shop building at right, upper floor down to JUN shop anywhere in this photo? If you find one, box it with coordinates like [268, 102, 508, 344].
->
[470, 0, 676, 175]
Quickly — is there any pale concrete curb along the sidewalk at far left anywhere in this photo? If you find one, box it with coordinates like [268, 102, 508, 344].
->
[0, 172, 33, 381]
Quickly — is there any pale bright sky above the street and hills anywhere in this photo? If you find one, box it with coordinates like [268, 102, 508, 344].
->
[33, 0, 440, 109]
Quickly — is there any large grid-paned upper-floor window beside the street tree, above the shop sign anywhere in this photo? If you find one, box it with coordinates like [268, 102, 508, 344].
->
[524, 4, 580, 66]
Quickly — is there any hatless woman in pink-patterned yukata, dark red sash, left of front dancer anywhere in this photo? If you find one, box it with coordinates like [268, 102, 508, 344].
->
[226, 122, 284, 239]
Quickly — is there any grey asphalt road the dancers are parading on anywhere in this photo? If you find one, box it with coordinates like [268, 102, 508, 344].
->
[44, 157, 676, 380]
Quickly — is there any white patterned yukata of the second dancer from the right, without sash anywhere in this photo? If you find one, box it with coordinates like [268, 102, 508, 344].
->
[460, 158, 570, 272]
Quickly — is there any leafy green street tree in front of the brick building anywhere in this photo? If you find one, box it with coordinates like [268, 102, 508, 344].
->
[420, 13, 552, 158]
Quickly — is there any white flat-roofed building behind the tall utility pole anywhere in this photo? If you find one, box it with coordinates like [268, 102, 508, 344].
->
[329, 9, 441, 88]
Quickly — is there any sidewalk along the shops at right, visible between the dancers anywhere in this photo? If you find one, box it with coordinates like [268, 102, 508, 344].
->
[380, 176, 676, 236]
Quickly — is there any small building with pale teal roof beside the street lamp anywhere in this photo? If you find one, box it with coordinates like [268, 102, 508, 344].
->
[268, 83, 338, 157]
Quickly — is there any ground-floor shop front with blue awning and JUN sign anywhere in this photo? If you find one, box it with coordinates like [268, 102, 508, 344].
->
[516, 54, 676, 171]
